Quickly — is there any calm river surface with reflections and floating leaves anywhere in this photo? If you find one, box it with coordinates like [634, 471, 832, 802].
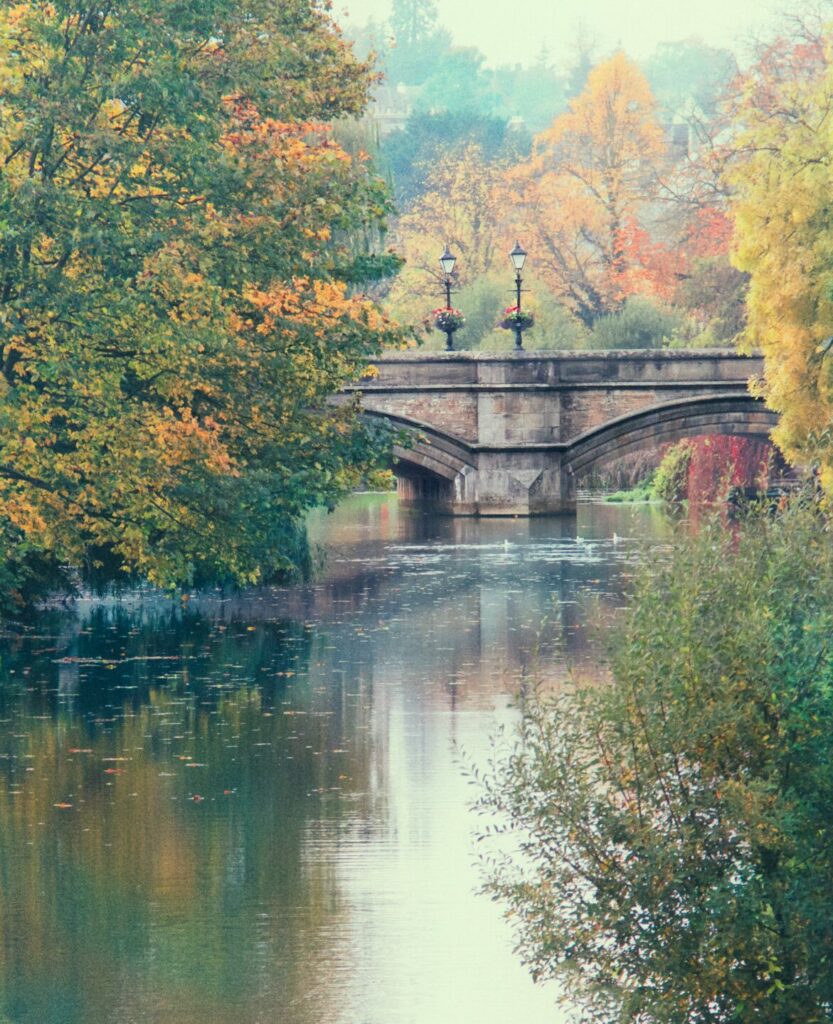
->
[0, 496, 669, 1024]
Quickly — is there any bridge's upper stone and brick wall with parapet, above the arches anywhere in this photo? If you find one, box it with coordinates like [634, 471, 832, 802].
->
[360, 349, 762, 445]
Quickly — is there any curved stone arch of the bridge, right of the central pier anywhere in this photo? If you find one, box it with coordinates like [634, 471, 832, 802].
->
[564, 391, 778, 477]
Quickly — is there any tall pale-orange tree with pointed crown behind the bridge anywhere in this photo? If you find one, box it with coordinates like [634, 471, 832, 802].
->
[508, 52, 670, 327]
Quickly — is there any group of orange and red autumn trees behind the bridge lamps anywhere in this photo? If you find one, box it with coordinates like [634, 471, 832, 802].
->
[389, 52, 745, 347]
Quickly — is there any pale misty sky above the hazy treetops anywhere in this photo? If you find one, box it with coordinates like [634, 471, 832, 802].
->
[334, 0, 794, 65]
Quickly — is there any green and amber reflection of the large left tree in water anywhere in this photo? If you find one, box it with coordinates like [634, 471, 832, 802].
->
[0, 608, 379, 1024]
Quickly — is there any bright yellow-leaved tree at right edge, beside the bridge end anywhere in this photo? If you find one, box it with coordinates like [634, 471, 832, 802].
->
[731, 39, 833, 488]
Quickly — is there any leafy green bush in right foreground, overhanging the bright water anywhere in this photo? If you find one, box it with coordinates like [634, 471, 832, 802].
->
[482, 503, 833, 1024]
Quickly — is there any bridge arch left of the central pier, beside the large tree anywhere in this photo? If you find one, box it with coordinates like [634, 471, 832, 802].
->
[362, 409, 477, 511]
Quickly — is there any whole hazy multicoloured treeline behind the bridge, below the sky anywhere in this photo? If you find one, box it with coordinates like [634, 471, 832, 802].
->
[334, 0, 803, 350]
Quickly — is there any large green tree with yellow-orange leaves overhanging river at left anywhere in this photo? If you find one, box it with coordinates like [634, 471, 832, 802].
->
[0, 0, 399, 598]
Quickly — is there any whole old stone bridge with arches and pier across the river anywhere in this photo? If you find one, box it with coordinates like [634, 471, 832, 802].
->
[342, 349, 777, 515]
